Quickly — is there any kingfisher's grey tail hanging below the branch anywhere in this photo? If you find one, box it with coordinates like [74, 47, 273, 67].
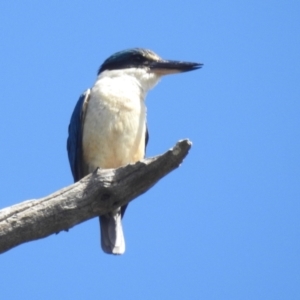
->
[99, 208, 125, 254]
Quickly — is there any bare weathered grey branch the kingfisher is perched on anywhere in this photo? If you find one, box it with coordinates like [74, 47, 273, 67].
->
[0, 140, 191, 253]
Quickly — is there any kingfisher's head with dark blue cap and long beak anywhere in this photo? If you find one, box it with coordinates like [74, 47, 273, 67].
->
[98, 48, 203, 91]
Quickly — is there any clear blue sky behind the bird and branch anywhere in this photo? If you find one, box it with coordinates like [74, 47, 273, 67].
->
[0, 0, 300, 300]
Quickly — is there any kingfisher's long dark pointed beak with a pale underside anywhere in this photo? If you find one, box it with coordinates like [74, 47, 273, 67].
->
[149, 60, 203, 75]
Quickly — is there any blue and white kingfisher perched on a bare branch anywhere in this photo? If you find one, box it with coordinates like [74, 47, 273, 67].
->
[67, 48, 203, 255]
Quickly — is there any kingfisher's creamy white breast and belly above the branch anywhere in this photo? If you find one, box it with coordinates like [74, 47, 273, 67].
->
[83, 71, 146, 172]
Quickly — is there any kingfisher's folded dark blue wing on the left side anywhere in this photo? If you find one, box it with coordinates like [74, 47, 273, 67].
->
[67, 89, 90, 182]
